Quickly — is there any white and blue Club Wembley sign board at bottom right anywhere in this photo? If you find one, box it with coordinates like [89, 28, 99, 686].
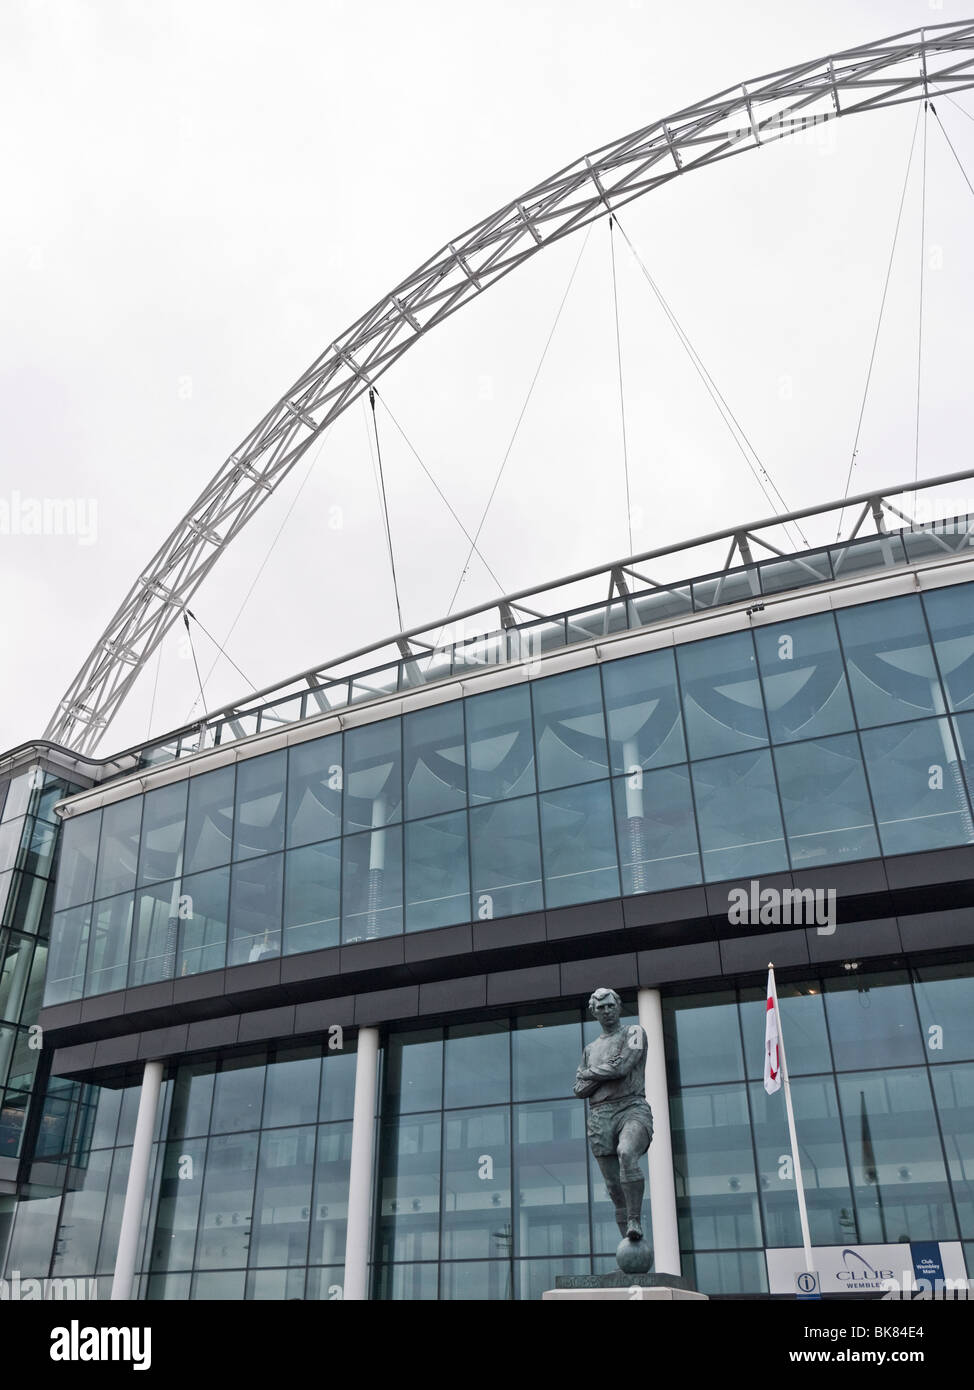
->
[764, 1240, 967, 1298]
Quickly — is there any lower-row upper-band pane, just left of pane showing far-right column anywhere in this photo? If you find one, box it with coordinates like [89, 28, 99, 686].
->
[774, 734, 880, 869]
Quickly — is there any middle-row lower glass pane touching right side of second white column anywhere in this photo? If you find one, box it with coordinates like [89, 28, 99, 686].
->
[377, 1115, 440, 1264]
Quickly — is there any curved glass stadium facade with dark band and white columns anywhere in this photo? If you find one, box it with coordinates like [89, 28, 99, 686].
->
[0, 492, 974, 1301]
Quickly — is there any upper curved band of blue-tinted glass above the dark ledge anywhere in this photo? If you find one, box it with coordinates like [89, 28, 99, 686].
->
[47, 585, 974, 1005]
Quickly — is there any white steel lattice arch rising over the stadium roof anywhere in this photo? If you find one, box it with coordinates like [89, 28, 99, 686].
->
[44, 19, 974, 752]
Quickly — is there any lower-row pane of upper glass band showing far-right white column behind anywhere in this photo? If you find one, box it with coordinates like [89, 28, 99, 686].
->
[861, 719, 974, 855]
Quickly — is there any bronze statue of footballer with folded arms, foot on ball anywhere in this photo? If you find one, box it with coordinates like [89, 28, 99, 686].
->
[574, 988, 653, 1269]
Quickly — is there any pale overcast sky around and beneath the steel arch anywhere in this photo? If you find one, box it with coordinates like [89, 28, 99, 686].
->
[0, 0, 974, 755]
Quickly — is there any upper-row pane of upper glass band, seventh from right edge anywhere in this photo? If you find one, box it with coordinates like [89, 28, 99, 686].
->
[464, 685, 535, 802]
